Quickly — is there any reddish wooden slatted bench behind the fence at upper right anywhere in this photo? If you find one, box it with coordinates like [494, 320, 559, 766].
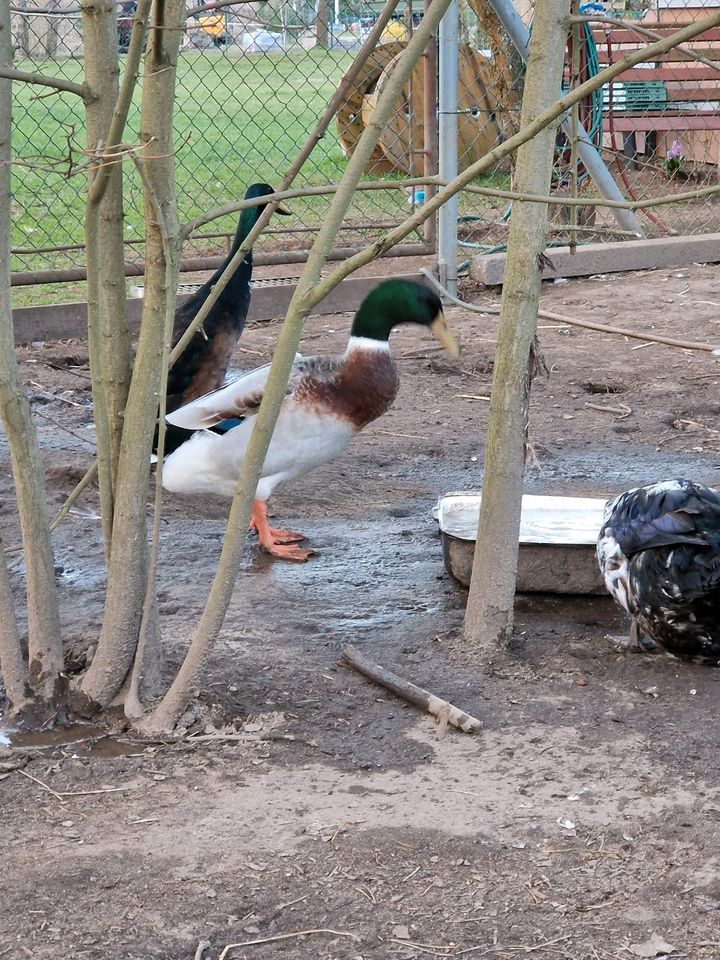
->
[593, 7, 720, 164]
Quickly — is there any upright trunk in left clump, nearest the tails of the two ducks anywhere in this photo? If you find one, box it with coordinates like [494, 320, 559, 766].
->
[80, 0, 185, 711]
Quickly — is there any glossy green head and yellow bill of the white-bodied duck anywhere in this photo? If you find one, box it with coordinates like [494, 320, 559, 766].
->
[350, 280, 460, 357]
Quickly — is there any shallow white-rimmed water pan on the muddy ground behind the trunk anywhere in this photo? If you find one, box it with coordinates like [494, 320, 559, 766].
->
[436, 493, 606, 594]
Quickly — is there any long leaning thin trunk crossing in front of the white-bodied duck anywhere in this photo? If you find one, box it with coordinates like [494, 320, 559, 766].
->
[140, 0, 449, 733]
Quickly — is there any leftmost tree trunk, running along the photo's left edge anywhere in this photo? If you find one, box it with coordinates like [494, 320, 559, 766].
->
[0, 3, 63, 703]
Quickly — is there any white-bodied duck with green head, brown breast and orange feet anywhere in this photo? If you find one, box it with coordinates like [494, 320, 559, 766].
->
[163, 280, 459, 561]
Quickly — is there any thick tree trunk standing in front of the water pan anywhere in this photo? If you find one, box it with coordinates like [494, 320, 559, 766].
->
[465, 0, 570, 659]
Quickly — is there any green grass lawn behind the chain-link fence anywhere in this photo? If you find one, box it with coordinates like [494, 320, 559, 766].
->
[12, 47, 505, 284]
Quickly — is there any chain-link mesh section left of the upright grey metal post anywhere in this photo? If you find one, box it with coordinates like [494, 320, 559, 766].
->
[11, 0, 434, 271]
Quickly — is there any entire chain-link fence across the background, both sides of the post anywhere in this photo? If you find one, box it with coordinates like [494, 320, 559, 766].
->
[7, 0, 720, 282]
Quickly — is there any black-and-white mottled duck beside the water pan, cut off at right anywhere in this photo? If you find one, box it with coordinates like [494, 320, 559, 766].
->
[597, 480, 720, 665]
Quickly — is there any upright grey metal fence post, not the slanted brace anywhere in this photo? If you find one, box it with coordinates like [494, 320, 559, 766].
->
[438, 0, 460, 297]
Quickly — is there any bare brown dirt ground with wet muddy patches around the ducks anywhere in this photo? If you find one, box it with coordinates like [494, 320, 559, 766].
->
[0, 265, 720, 960]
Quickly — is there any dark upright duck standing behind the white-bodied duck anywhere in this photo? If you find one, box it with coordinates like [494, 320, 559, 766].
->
[165, 183, 290, 454]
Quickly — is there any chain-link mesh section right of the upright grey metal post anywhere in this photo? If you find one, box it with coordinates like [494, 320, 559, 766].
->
[458, 0, 720, 256]
